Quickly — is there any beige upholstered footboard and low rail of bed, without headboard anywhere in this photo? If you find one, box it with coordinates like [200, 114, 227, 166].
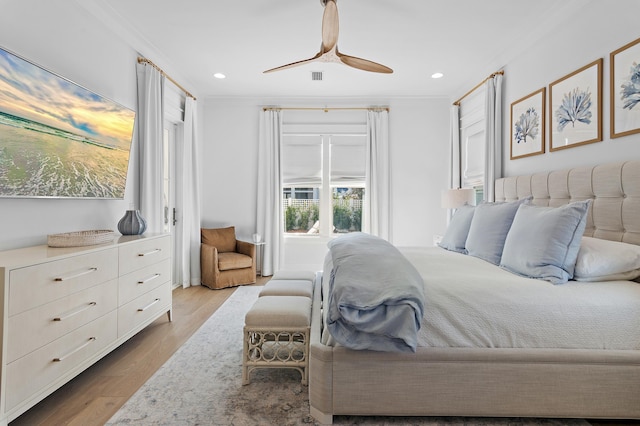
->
[309, 276, 640, 424]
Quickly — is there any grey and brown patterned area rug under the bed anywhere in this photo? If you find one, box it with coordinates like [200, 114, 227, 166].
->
[107, 286, 589, 426]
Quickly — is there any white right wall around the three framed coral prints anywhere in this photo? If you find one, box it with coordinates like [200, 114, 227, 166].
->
[504, 0, 640, 176]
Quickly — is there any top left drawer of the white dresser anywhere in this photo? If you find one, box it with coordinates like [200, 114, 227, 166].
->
[9, 247, 118, 316]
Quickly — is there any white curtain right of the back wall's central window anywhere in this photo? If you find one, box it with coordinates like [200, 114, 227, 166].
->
[362, 110, 391, 241]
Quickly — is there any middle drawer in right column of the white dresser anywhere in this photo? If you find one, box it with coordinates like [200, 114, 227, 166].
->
[118, 259, 171, 306]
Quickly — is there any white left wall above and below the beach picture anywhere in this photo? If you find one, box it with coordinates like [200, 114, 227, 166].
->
[0, 0, 137, 249]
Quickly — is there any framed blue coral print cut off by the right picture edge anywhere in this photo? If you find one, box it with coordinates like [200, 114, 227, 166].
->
[610, 38, 640, 138]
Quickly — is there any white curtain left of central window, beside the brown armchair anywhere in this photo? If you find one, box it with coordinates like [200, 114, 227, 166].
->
[256, 110, 284, 276]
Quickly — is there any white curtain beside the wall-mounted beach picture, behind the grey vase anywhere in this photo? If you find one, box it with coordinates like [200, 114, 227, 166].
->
[136, 63, 165, 233]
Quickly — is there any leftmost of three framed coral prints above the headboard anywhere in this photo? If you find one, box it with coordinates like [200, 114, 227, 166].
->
[511, 87, 546, 160]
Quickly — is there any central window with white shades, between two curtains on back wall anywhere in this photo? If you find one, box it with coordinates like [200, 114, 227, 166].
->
[282, 133, 366, 236]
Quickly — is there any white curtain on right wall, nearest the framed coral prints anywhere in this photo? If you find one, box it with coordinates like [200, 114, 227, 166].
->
[484, 74, 502, 202]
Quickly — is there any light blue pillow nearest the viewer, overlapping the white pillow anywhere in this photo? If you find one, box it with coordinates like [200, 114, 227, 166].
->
[500, 200, 591, 284]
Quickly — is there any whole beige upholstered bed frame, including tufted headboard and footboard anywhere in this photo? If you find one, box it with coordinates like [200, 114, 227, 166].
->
[309, 161, 640, 424]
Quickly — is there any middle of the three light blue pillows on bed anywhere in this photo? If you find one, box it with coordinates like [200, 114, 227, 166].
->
[465, 197, 531, 265]
